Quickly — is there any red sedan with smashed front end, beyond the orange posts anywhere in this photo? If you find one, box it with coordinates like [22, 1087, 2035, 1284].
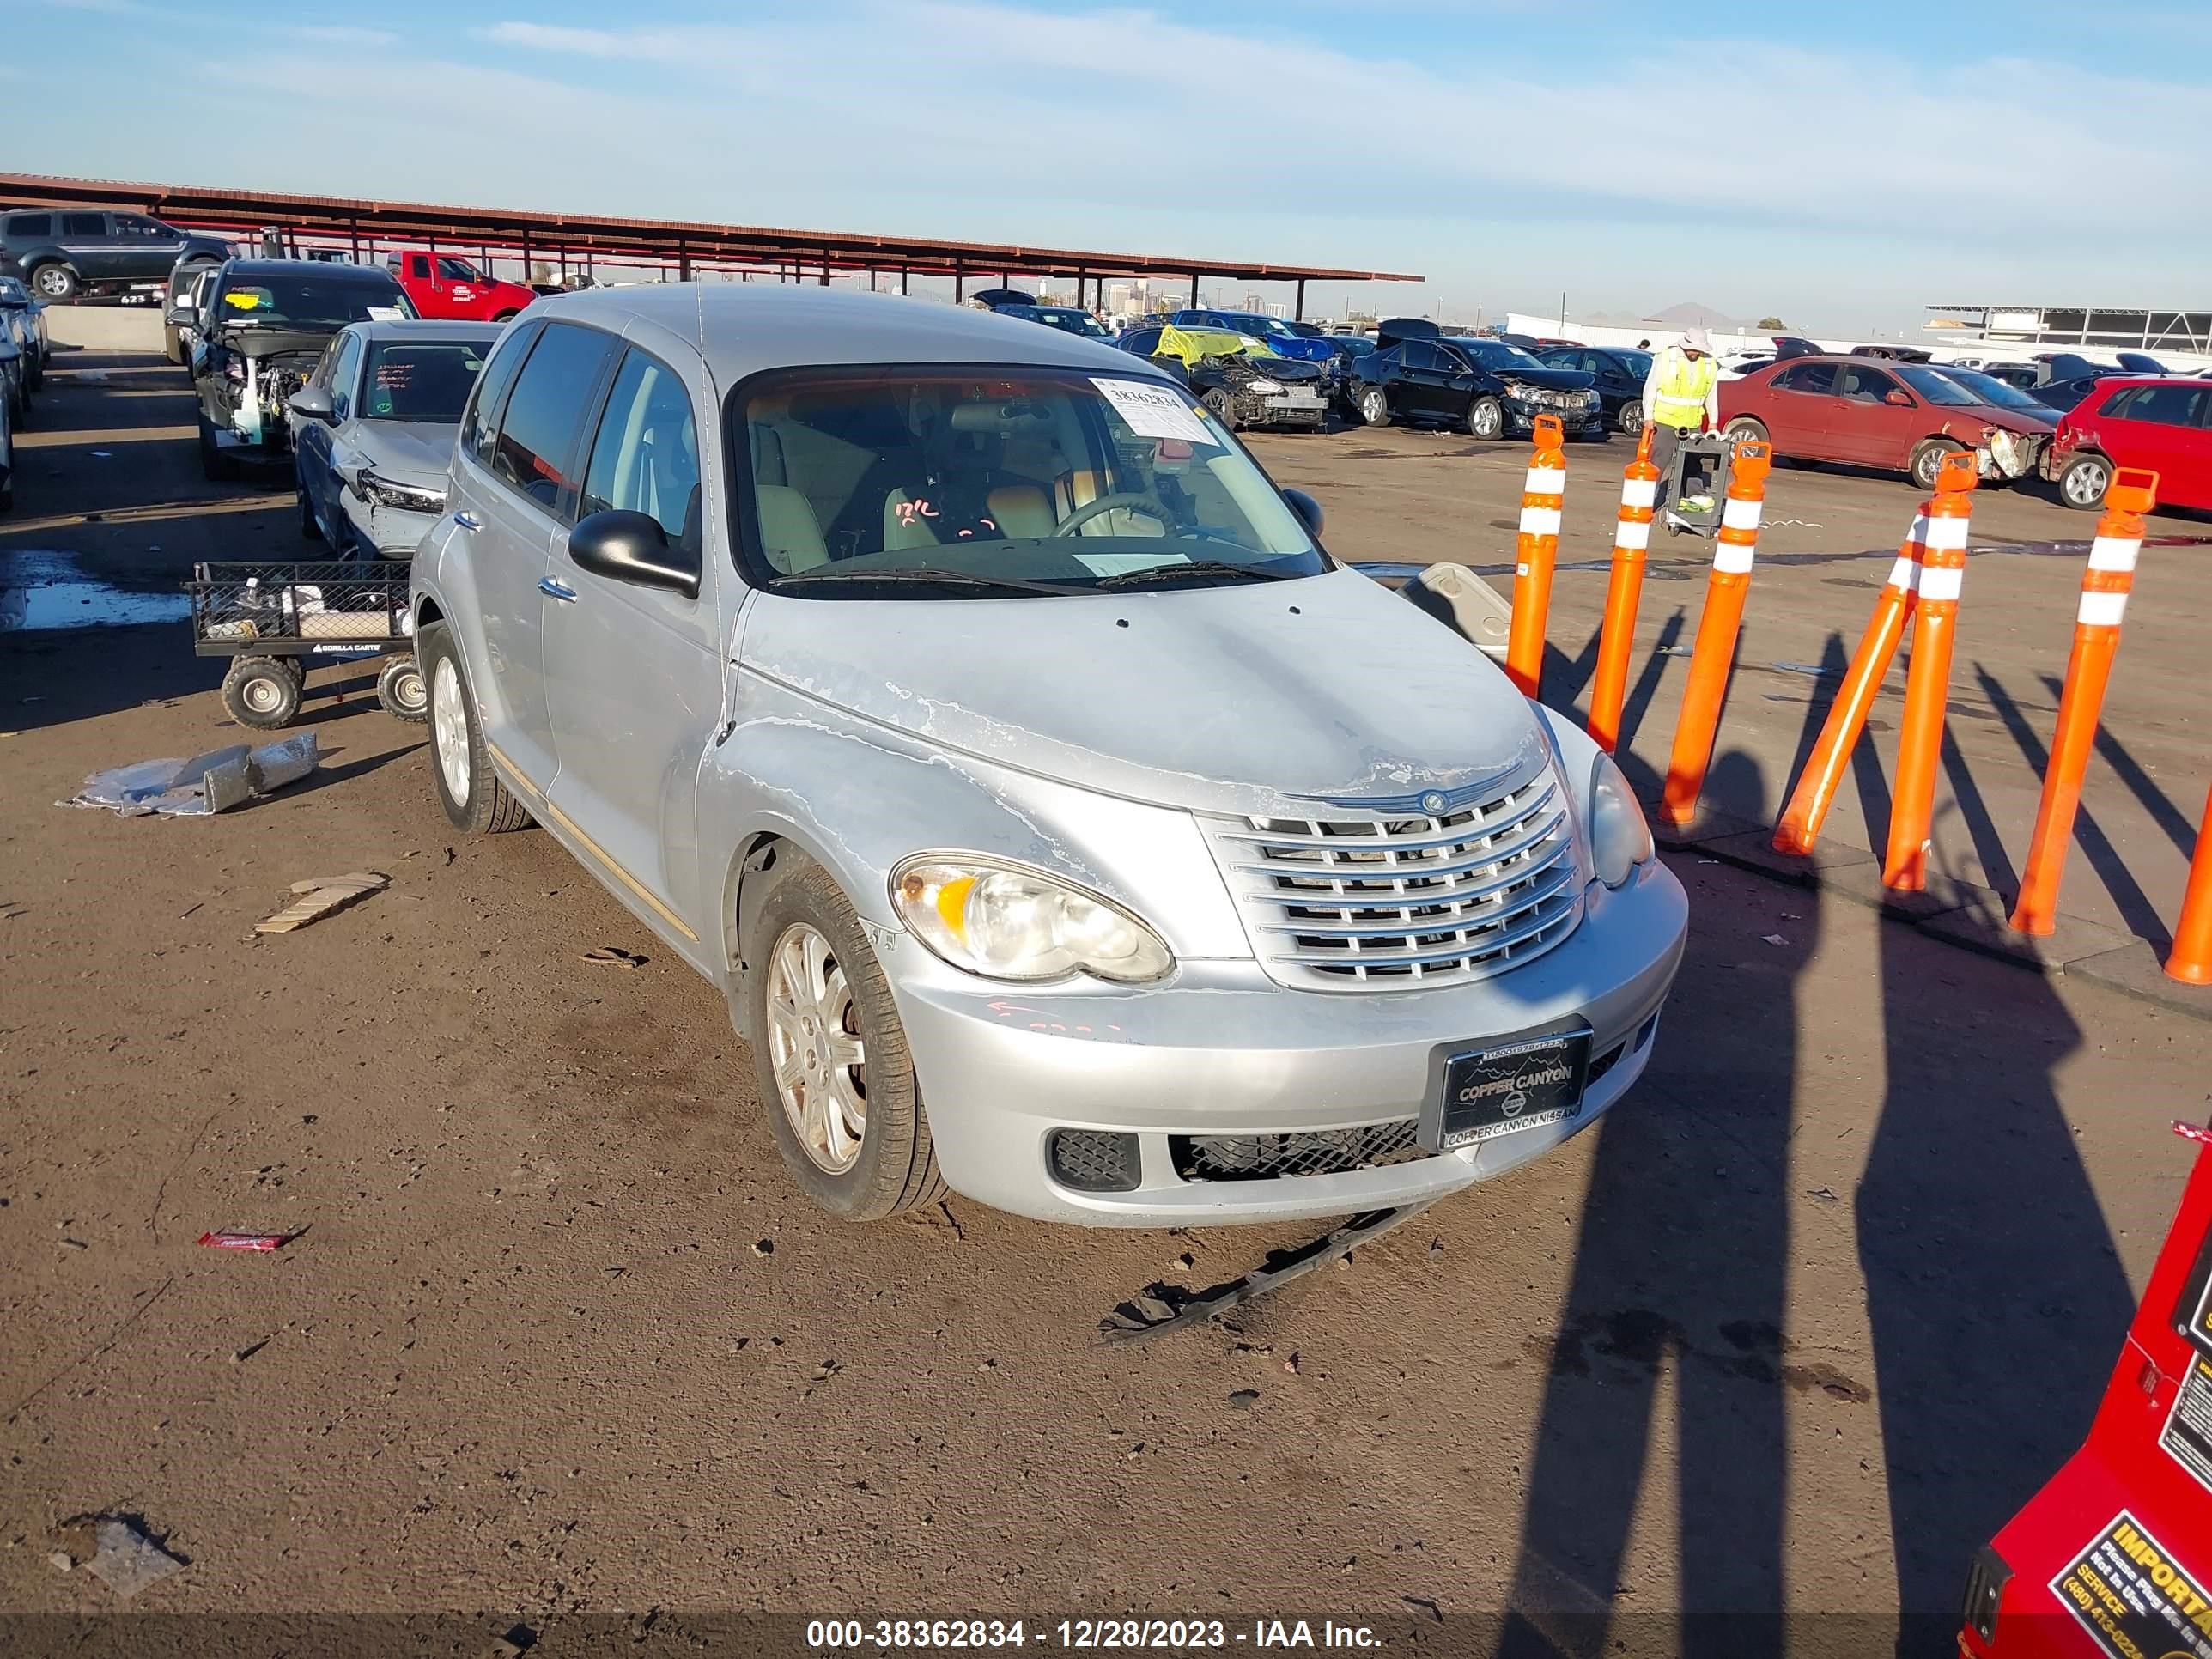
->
[1721, 356, 2057, 489]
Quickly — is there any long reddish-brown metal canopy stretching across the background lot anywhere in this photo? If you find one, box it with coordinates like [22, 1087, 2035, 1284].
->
[0, 173, 1422, 316]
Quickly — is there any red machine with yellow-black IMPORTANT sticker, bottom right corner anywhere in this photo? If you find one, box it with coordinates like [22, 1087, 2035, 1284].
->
[1958, 1124, 2212, 1659]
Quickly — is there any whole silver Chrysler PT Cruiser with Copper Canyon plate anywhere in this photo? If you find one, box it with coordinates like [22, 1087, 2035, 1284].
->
[411, 285, 1687, 1225]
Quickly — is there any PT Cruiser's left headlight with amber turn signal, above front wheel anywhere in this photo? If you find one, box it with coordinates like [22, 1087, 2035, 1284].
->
[891, 854, 1175, 984]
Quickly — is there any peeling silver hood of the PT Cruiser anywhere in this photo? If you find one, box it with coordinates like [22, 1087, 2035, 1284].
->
[738, 571, 1547, 817]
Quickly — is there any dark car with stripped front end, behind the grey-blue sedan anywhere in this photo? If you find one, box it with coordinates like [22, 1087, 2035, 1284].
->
[181, 258, 416, 480]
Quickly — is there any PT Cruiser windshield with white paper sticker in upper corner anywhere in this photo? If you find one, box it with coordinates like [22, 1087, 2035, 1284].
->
[732, 368, 1332, 599]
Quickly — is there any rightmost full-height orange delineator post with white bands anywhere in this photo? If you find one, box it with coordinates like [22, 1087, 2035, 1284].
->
[2013, 467, 2159, 936]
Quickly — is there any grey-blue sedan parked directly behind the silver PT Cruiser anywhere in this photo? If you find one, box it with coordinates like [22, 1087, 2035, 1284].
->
[285, 323, 504, 560]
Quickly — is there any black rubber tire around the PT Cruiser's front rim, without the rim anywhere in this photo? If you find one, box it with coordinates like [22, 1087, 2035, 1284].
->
[738, 849, 947, 1221]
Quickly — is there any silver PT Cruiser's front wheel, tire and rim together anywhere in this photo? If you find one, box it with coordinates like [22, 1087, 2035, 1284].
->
[741, 849, 945, 1221]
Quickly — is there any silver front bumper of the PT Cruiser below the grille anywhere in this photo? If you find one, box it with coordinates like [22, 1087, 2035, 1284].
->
[883, 860, 1687, 1228]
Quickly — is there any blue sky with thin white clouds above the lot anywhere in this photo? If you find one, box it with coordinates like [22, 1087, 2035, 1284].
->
[0, 0, 2212, 331]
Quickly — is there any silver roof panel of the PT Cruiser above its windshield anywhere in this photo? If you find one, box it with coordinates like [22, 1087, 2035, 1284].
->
[513, 283, 1152, 385]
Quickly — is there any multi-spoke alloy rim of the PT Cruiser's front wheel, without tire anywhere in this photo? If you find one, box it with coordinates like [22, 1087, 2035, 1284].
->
[768, 922, 867, 1175]
